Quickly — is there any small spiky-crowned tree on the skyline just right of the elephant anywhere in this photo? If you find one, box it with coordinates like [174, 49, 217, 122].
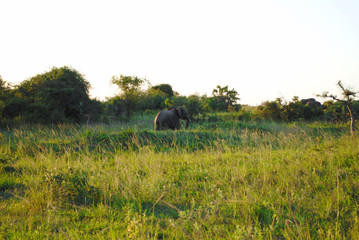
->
[211, 85, 240, 111]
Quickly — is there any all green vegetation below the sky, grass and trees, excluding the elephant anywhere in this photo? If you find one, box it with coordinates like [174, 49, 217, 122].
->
[0, 67, 359, 239]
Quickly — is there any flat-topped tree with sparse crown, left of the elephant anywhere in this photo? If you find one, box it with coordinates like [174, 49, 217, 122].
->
[111, 75, 148, 117]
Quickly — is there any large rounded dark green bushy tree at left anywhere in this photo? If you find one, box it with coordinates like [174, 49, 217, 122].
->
[16, 67, 91, 123]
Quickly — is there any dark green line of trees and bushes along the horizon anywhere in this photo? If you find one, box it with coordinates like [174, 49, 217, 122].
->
[0, 66, 359, 129]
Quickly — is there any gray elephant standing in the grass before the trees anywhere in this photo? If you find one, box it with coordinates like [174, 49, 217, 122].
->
[154, 106, 190, 130]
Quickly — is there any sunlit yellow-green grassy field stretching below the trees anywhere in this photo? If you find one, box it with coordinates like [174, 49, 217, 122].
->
[0, 115, 359, 239]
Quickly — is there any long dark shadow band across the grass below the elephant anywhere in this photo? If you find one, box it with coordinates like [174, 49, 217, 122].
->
[21, 121, 354, 156]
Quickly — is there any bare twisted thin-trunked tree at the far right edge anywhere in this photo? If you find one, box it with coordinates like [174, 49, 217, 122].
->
[318, 80, 358, 136]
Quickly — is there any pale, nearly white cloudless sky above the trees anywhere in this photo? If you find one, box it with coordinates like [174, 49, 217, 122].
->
[0, 0, 359, 105]
